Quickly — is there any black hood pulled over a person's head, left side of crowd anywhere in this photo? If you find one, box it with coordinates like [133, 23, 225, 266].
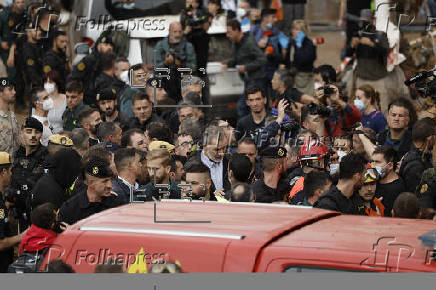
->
[49, 149, 81, 189]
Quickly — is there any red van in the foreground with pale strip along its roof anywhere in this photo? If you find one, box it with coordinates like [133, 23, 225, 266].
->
[42, 200, 436, 273]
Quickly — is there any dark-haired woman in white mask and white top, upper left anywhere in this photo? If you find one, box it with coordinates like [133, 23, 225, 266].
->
[43, 70, 67, 134]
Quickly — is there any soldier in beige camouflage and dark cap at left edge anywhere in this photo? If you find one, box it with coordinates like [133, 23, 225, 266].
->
[0, 78, 20, 159]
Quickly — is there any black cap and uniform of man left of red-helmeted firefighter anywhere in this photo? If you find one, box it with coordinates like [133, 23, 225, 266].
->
[252, 146, 287, 203]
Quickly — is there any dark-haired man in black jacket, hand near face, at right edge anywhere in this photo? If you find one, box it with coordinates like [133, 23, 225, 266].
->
[399, 118, 436, 192]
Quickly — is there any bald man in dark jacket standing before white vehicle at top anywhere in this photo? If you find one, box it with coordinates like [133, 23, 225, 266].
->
[152, 22, 197, 71]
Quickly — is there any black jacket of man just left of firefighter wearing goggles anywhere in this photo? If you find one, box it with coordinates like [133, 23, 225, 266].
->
[313, 186, 359, 214]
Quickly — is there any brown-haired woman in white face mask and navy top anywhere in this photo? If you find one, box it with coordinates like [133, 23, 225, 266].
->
[354, 85, 387, 134]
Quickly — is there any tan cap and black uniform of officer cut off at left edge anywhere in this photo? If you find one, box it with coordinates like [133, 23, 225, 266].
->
[0, 152, 14, 273]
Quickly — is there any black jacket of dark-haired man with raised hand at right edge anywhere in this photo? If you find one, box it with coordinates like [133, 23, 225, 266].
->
[399, 146, 433, 192]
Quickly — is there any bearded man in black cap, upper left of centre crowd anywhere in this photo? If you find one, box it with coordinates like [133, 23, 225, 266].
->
[96, 88, 130, 124]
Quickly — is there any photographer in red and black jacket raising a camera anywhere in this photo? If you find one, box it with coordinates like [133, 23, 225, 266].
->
[318, 84, 362, 138]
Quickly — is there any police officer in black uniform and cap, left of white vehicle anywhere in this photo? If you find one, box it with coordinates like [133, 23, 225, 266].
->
[70, 32, 114, 105]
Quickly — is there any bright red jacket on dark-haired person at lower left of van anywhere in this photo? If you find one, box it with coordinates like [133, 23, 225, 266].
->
[18, 225, 57, 255]
